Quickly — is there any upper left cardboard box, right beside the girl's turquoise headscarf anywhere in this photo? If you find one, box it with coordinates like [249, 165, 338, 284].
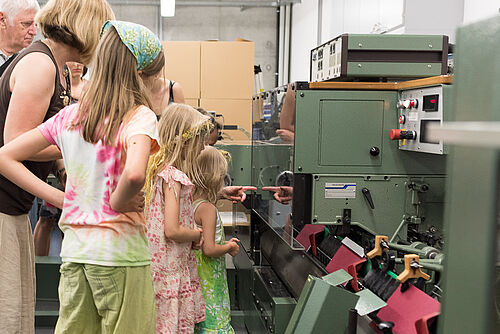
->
[162, 41, 201, 100]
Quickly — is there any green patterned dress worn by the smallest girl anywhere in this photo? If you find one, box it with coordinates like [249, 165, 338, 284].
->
[193, 200, 234, 334]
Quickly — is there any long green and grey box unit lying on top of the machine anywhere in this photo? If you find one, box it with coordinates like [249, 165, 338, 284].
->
[309, 34, 449, 82]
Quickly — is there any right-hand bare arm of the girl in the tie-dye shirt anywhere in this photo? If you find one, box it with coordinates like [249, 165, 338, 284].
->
[109, 135, 151, 212]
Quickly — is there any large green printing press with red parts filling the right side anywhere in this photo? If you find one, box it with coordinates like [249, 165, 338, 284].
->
[37, 26, 500, 334]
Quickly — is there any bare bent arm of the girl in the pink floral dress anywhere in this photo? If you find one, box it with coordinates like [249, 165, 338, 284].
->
[162, 181, 202, 243]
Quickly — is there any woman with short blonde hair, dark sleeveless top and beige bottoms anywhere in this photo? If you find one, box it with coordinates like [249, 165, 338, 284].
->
[0, 0, 114, 334]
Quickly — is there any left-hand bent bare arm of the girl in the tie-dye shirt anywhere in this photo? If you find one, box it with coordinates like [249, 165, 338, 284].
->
[0, 129, 64, 209]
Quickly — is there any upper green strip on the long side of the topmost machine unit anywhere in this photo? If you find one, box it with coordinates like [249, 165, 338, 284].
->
[347, 34, 443, 51]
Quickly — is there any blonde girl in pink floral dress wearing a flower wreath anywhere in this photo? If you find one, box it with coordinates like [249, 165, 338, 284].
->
[146, 103, 212, 334]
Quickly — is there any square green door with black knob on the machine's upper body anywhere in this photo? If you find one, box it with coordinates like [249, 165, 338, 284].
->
[319, 100, 384, 166]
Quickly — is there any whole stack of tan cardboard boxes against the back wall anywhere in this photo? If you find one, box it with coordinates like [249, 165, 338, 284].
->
[163, 41, 254, 140]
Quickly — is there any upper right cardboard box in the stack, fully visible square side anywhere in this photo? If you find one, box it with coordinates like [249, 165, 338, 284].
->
[201, 41, 254, 100]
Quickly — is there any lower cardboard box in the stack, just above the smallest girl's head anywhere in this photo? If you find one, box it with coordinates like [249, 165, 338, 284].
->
[200, 98, 252, 140]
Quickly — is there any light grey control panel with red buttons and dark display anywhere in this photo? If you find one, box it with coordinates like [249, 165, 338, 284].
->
[390, 86, 446, 154]
